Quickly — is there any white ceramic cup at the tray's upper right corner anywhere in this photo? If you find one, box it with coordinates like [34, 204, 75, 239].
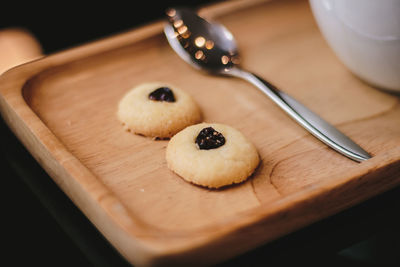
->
[309, 0, 400, 92]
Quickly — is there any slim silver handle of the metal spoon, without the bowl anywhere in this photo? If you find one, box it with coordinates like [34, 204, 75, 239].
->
[229, 68, 371, 162]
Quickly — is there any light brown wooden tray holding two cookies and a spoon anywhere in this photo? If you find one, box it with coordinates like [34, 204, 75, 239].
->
[0, 0, 400, 266]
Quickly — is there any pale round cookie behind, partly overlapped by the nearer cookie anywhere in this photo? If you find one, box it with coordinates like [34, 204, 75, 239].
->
[117, 82, 201, 138]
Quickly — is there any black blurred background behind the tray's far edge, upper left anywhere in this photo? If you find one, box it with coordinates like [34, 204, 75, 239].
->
[0, 0, 216, 54]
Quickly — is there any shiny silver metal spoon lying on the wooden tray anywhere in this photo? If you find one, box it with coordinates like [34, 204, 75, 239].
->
[164, 9, 371, 162]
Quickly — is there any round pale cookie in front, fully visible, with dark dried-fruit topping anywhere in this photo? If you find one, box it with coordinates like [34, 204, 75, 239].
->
[166, 123, 260, 188]
